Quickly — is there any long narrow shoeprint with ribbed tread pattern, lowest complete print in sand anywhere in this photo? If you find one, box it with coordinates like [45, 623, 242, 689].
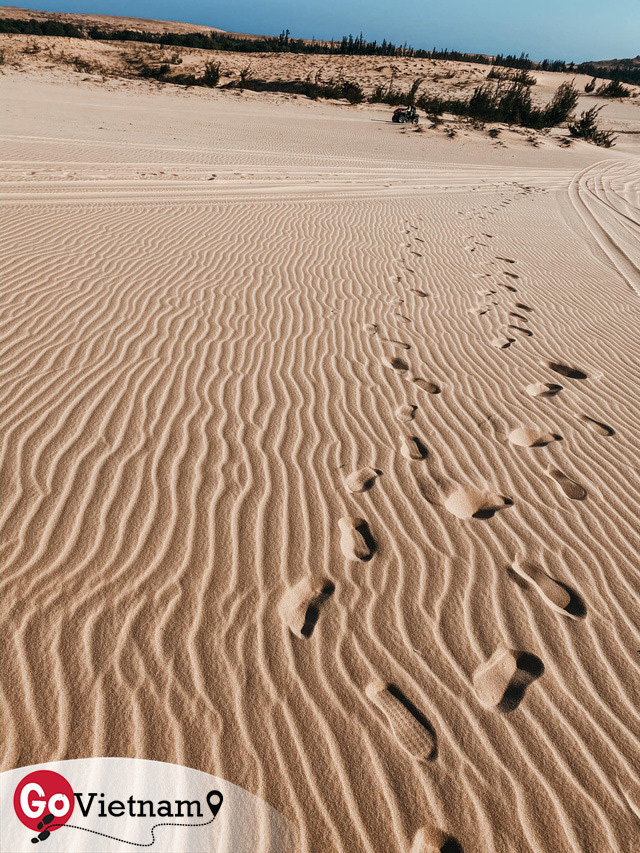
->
[365, 681, 436, 761]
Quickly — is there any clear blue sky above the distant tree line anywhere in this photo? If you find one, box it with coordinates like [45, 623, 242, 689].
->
[9, 0, 640, 62]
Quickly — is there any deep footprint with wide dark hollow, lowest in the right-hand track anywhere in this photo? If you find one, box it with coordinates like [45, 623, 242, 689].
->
[473, 645, 544, 712]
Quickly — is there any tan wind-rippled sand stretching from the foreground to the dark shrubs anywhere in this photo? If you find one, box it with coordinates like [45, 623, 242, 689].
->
[0, 15, 640, 853]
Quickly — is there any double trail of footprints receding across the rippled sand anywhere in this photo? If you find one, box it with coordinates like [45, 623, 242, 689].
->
[281, 218, 615, 853]
